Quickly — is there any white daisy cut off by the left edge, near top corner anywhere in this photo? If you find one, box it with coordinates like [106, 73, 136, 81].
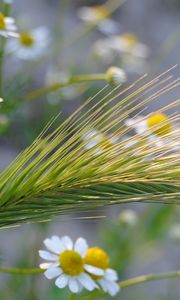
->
[0, 12, 18, 38]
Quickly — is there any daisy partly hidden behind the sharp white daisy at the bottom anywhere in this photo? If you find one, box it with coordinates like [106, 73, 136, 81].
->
[84, 247, 120, 296]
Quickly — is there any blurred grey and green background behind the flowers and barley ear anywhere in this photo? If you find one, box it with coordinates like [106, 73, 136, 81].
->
[0, 0, 180, 300]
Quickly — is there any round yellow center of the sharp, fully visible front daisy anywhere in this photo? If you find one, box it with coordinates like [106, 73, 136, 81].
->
[59, 250, 84, 276]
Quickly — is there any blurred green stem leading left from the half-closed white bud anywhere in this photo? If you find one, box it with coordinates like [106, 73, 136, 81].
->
[20, 73, 106, 102]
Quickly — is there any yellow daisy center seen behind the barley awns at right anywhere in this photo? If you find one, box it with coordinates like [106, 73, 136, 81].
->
[147, 113, 171, 136]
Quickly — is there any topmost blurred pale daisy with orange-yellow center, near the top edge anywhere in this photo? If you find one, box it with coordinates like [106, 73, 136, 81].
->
[78, 5, 118, 34]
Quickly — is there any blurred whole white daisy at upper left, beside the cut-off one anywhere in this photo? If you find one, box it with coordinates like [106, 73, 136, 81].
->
[8, 27, 50, 60]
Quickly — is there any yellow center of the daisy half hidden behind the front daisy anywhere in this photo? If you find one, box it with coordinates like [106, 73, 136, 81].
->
[84, 247, 109, 279]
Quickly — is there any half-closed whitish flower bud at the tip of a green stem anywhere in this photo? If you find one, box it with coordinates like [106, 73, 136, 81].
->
[106, 67, 127, 86]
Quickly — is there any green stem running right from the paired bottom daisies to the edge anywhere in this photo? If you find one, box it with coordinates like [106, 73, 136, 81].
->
[119, 271, 180, 288]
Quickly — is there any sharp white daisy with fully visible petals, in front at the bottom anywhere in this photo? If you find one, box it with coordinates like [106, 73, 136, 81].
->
[39, 236, 100, 293]
